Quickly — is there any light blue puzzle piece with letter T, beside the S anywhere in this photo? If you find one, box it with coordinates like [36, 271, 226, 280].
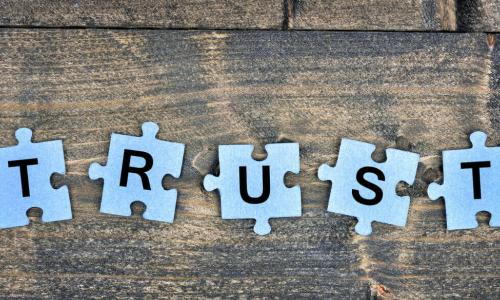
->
[427, 131, 500, 230]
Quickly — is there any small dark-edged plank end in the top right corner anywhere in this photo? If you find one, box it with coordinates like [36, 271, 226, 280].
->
[457, 0, 500, 32]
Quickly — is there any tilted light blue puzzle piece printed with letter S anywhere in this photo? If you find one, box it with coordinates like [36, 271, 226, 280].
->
[318, 139, 419, 235]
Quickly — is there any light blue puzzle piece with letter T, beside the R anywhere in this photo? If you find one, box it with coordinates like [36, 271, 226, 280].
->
[0, 128, 72, 228]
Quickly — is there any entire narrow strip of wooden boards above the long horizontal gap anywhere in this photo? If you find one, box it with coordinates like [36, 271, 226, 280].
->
[0, 0, 500, 32]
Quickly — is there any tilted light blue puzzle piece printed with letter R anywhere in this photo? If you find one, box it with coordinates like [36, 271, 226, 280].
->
[89, 122, 184, 223]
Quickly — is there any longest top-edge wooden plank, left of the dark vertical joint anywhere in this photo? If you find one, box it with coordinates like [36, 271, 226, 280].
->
[0, 0, 284, 29]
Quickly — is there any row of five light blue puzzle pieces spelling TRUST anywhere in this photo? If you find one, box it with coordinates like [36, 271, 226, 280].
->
[0, 122, 500, 235]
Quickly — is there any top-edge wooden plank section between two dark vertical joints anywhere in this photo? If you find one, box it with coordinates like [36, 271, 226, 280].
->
[288, 0, 456, 31]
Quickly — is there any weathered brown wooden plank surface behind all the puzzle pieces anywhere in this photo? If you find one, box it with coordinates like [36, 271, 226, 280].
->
[0, 0, 500, 299]
